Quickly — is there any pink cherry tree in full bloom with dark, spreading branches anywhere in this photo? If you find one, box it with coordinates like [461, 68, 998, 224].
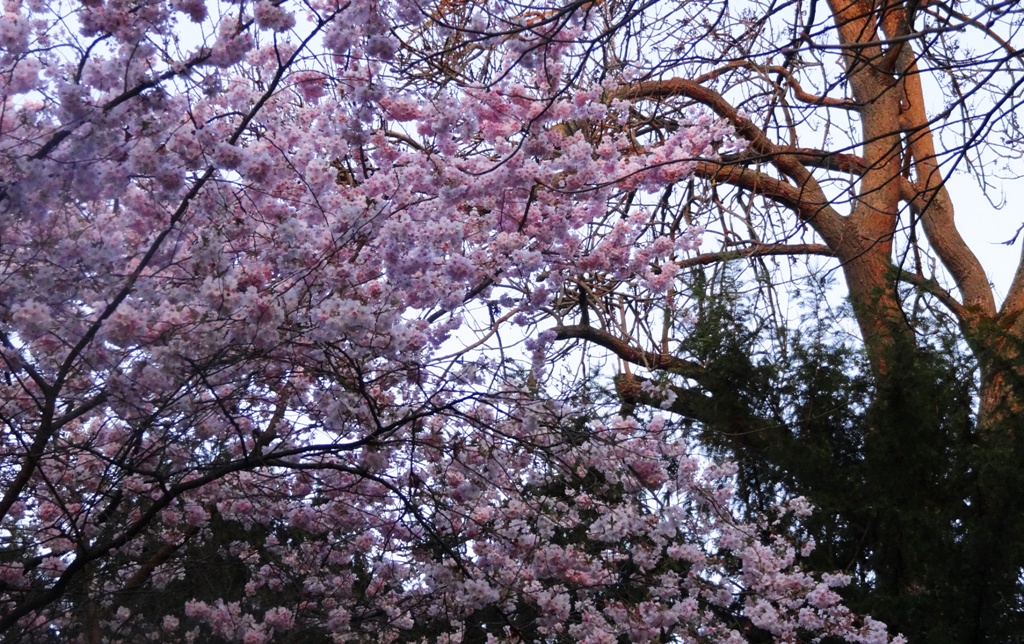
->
[0, 0, 887, 643]
